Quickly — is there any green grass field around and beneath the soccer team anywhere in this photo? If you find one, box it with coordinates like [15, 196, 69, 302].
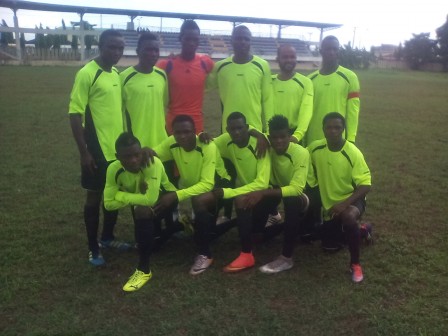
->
[0, 66, 448, 336]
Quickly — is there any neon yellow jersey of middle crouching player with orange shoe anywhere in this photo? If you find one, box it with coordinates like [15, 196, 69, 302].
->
[214, 133, 271, 198]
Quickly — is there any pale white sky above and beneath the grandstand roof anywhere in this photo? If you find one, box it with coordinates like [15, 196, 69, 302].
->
[0, 0, 448, 49]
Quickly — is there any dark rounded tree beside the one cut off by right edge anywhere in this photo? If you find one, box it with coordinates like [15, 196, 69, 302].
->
[403, 33, 436, 70]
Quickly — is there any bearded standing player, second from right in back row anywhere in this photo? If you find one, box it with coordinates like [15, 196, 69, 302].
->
[266, 44, 313, 225]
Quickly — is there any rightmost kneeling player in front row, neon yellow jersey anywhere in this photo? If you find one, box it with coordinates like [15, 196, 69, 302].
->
[308, 112, 371, 282]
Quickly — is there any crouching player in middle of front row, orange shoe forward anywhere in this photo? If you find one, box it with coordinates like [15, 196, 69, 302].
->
[213, 112, 271, 273]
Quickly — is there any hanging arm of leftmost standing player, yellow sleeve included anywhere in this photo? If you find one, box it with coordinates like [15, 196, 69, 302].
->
[69, 71, 96, 173]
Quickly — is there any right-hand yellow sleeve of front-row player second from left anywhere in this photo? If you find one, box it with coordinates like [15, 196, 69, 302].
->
[176, 142, 216, 202]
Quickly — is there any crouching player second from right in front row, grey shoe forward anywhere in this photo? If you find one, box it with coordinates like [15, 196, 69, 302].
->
[242, 115, 310, 273]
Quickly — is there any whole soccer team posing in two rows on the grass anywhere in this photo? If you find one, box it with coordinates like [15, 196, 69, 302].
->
[69, 20, 371, 291]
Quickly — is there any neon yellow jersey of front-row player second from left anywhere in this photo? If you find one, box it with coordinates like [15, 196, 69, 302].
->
[154, 136, 216, 201]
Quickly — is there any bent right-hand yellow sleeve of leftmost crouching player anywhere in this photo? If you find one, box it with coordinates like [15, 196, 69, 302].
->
[115, 160, 164, 206]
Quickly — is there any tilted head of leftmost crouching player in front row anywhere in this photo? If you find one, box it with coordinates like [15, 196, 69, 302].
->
[115, 132, 142, 173]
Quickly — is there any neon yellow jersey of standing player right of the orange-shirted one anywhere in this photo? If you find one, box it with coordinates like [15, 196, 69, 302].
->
[210, 56, 274, 132]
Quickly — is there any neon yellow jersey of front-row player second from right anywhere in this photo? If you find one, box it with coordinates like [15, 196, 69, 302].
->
[270, 142, 310, 197]
